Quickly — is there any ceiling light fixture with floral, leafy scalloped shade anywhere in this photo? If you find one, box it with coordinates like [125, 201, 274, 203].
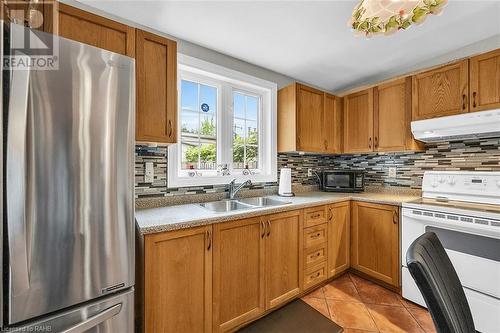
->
[349, 0, 448, 37]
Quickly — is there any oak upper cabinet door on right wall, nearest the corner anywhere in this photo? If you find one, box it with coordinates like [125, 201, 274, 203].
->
[344, 89, 373, 153]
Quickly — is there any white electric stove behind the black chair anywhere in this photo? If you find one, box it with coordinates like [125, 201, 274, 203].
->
[401, 171, 500, 333]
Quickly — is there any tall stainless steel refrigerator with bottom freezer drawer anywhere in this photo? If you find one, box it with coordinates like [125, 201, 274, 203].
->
[0, 24, 135, 333]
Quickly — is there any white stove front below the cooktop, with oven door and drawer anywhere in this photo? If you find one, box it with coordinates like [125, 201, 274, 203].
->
[401, 208, 500, 333]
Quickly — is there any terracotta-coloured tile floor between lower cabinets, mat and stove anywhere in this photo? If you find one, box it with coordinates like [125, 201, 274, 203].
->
[302, 273, 436, 333]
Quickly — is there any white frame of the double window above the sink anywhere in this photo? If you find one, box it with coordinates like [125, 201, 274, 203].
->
[167, 54, 277, 187]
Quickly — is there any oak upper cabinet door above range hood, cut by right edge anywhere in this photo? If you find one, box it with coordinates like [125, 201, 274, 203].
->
[470, 49, 500, 111]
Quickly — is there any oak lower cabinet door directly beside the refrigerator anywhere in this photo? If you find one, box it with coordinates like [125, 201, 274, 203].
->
[144, 226, 212, 333]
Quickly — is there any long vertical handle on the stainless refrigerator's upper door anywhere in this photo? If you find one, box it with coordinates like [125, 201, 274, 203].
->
[6, 56, 30, 296]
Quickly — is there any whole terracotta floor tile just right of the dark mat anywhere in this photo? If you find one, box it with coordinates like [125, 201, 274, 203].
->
[326, 300, 377, 331]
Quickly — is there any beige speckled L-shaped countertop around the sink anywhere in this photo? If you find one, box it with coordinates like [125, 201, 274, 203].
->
[135, 192, 420, 235]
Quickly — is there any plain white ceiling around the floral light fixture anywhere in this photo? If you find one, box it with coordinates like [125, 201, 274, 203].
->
[79, 0, 500, 91]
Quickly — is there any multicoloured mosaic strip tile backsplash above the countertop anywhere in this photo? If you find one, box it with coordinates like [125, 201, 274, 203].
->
[135, 138, 500, 198]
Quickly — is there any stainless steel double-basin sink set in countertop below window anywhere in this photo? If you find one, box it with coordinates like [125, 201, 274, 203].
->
[200, 197, 291, 213]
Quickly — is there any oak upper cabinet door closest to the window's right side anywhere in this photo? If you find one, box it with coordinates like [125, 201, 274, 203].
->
[297, 84, 324, 152]
